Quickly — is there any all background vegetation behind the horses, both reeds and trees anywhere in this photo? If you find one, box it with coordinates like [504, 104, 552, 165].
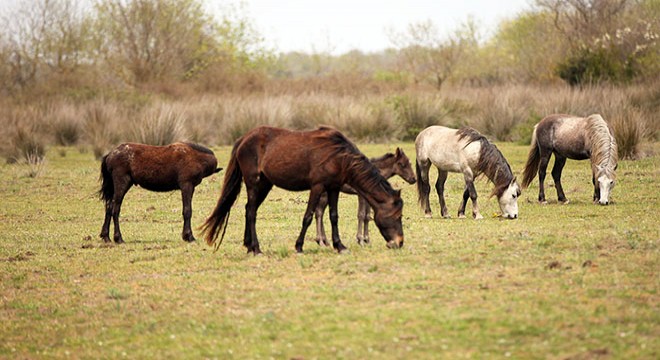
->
[0, 0, 660, 162]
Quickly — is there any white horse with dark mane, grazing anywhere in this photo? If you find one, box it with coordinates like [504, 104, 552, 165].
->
[415, 126, 520, 219]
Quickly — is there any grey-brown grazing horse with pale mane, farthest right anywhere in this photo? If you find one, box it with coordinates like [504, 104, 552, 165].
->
[522, 114, 618, 205]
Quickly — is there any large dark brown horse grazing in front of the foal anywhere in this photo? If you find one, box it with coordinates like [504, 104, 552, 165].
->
[203, 126, 403, 255]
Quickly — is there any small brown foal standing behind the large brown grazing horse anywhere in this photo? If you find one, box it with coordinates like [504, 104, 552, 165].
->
[314, 148, 415, 246]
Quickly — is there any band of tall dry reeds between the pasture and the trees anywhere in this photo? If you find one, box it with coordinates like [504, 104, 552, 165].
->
[0, 82, 660, 158]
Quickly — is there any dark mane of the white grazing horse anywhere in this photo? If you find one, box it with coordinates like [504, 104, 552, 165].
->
[457, 127, 513, 197]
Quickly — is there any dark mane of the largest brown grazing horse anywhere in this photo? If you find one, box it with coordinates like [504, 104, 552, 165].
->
[317, 126, 395, 198]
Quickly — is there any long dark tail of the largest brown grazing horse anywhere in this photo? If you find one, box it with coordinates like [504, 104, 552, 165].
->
[202, 139, 243, 249]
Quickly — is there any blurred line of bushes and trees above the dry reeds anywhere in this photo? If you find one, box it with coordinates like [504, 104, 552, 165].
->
[0, 0, 660, 98]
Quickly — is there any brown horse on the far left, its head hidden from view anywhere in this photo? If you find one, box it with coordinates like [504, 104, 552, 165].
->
[99, 142, 222, 244]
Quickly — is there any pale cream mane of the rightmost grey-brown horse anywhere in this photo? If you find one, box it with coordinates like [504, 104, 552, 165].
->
[587, 114, 619, 178]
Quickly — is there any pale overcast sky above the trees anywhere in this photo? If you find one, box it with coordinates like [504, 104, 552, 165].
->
[240, 0, 530, 54]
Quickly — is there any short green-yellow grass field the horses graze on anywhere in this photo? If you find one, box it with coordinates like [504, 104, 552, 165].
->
[0, 143, 660, 359]
